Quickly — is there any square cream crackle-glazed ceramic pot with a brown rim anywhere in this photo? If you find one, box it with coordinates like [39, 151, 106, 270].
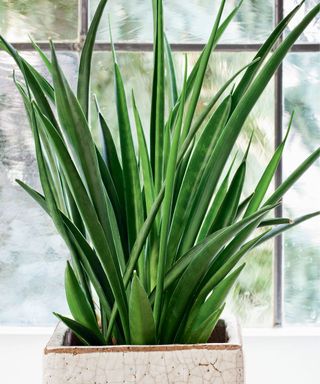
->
[43, 320, 244, 384]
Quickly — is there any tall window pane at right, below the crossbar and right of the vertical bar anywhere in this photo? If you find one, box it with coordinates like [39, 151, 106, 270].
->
[284, 53, 320, 324]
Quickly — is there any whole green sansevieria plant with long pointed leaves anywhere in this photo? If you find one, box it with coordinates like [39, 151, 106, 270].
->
[0, 0, 320, 345]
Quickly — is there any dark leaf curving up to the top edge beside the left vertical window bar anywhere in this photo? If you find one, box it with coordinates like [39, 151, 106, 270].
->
[77, 0, 108, 120]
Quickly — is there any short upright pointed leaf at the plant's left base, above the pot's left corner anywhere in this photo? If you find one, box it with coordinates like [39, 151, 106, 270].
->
[65, 262, 100, 334]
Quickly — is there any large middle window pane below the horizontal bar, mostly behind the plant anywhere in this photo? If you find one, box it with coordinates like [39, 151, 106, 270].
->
[93, 52, 274, 326]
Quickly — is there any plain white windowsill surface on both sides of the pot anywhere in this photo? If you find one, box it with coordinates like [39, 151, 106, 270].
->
[0, 329, 320, 384]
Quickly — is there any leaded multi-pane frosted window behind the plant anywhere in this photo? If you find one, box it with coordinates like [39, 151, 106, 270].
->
[0, 0, 320, 326]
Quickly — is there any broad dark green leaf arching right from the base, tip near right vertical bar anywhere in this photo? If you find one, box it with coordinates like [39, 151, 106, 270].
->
[162, 207, 273, 343]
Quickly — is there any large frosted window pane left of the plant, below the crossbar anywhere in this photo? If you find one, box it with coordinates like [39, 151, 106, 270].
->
[0, 53, 77, 326]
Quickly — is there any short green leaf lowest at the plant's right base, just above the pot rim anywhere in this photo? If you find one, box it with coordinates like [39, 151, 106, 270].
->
[182, 305, 225, 344]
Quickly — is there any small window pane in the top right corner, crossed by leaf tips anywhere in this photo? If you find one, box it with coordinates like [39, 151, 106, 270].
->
[284, 0, 320, 43]
